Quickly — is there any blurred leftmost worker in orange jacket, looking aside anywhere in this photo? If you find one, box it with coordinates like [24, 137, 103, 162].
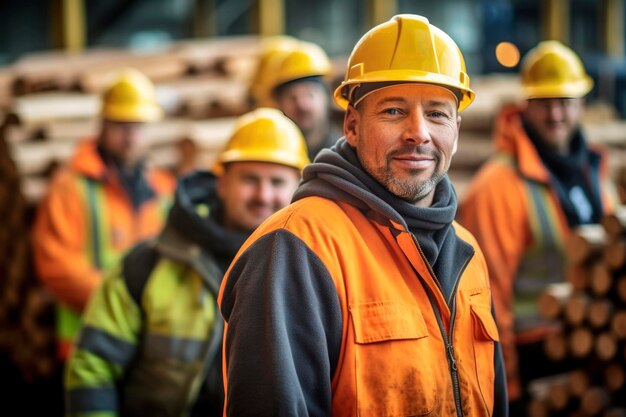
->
[33, 69, 175, 360]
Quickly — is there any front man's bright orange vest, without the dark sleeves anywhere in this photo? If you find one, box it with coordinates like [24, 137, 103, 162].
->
[219, 197, 498, 417]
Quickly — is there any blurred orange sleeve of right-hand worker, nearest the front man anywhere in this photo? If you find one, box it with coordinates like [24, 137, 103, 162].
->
[458, 165, 529, 400]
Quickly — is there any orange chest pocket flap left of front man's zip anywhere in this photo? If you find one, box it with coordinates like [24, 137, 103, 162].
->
[349, 301, 428, 343]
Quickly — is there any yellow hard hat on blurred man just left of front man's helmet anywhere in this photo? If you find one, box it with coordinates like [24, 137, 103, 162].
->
[270, 41, 332, 91]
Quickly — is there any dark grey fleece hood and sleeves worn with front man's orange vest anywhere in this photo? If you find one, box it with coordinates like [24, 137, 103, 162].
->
[221, 139, 507, 417]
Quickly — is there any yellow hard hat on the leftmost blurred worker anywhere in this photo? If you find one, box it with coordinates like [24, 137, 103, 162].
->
[102, 69, 163, 122]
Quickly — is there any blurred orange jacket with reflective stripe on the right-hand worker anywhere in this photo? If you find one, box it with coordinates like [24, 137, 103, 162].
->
[457, 106, 612, 399]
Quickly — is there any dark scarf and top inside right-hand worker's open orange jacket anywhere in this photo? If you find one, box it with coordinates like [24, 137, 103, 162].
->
[524, 123, 602, 226]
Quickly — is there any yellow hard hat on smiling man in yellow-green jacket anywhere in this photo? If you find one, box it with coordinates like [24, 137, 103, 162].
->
[213, 107, 310, 175]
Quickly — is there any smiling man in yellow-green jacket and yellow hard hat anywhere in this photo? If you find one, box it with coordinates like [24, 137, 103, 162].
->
[66, 108, 309, 417]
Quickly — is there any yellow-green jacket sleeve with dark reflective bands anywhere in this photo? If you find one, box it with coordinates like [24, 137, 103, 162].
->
[65, 267, 142, 417]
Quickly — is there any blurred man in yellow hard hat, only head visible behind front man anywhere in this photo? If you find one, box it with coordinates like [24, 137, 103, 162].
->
[265, 41, 341, 159]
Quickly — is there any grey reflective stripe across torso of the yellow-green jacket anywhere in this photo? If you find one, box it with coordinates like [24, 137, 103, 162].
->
[145, 333, 208, 362]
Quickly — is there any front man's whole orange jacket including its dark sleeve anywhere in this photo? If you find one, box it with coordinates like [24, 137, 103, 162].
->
[219, 196, 506, 417]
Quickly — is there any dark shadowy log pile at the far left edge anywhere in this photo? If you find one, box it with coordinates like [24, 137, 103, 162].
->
[0, 122, 58, 381]
